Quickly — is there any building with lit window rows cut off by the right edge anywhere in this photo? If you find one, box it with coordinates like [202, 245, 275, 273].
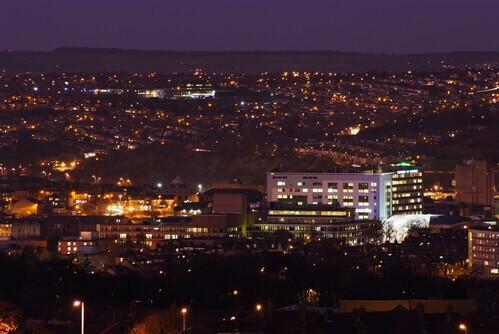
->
[468, 226, 499, 279]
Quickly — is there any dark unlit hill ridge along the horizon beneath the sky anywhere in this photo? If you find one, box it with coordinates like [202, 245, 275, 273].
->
[0, 48, 499, 73]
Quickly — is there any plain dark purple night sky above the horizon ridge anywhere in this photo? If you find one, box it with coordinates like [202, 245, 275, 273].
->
[0, 0, 499, 53]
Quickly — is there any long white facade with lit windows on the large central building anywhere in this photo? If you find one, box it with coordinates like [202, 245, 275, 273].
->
[267, 172, 392, 220]
